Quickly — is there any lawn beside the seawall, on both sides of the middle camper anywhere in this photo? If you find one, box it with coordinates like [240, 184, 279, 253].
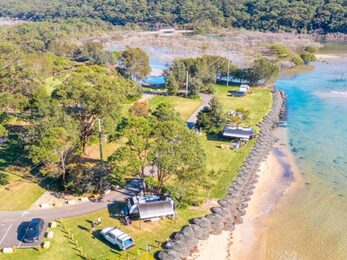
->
[201, 86, 272, 198]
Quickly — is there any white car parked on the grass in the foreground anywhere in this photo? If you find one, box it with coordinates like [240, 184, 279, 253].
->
[100, 227, 135, 250]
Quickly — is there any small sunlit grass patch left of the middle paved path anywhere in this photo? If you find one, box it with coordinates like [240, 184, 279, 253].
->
[149, 96, 202, 120]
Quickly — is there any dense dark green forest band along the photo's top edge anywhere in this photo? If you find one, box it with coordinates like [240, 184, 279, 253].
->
[0, 0, 347, 33]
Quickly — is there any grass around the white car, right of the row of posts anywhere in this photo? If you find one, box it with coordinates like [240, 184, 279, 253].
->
[64, 206, 207, 259]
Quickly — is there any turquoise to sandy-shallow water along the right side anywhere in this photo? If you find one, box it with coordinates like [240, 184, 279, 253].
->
[263, 45, 347, 260]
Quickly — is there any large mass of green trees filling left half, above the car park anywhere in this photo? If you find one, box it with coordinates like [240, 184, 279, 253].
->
[0, 19, 209, 207]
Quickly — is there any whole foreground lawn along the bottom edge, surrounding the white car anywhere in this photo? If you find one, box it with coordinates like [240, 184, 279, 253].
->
[0, 206, 208, 260]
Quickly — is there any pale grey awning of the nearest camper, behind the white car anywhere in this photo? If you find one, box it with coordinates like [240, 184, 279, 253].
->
[138, 200, 176, 219]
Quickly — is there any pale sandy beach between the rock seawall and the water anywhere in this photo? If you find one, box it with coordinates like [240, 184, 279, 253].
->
[192, 127, 299, 260]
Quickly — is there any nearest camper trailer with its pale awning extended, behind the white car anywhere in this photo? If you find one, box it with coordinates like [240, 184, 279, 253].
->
[123, 195, 176, 220]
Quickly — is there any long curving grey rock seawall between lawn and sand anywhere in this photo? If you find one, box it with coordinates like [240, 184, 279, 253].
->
[157, 88, 286, 260]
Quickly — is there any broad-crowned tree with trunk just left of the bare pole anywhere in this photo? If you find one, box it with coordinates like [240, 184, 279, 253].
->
[53, 65, 136, 152]
